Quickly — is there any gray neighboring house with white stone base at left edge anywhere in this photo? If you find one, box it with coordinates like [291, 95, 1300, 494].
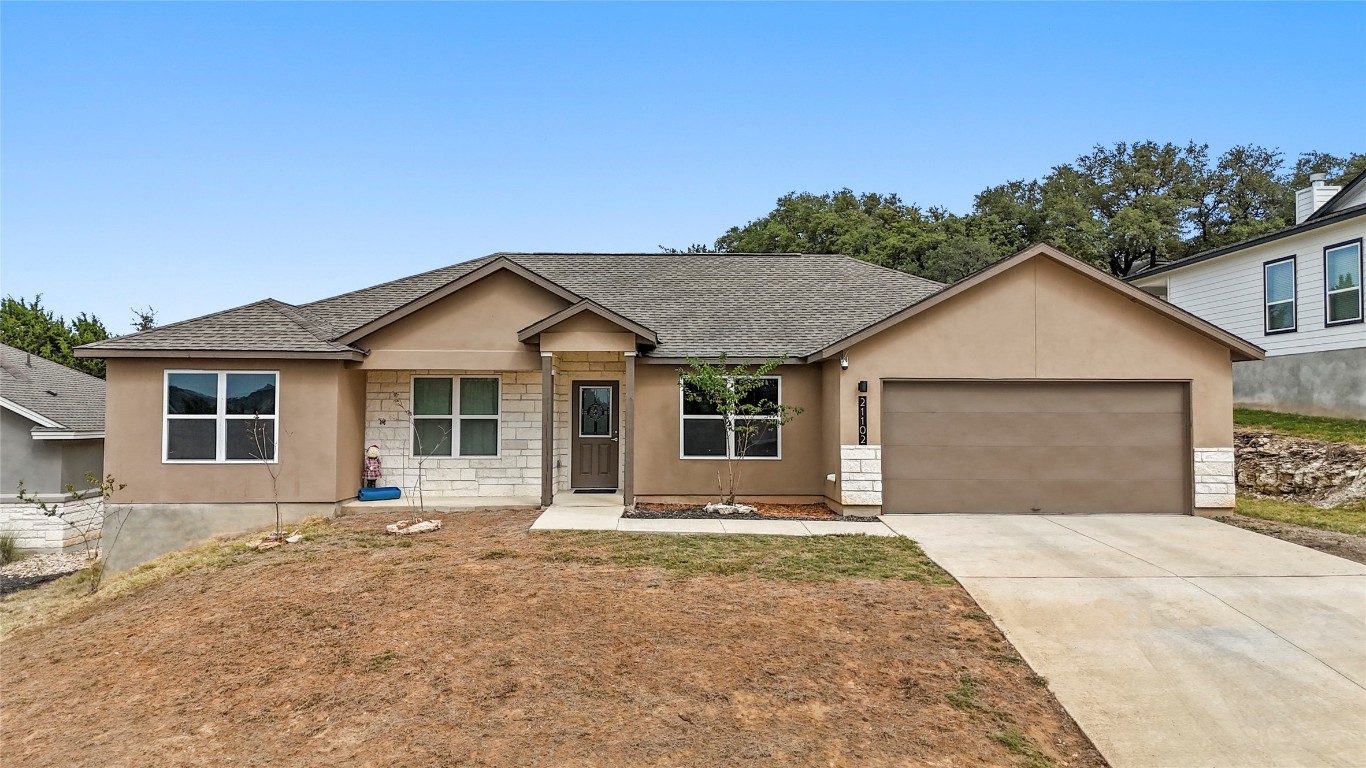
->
[0, 344, 104, 552]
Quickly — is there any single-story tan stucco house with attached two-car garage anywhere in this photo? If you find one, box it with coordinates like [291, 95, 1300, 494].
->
[78, 246, 1262, 568]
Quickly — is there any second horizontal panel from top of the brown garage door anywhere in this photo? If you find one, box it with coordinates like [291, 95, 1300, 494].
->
[882, 413, 1183, 445]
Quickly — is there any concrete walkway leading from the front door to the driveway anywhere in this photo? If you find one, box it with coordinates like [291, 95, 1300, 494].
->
[531, 493, 896, 536]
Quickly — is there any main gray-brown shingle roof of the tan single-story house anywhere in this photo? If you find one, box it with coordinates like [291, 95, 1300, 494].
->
[85, 253, 944, 358]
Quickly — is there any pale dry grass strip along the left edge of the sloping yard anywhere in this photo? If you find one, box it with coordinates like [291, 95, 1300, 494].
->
[0, 518, 331, 638]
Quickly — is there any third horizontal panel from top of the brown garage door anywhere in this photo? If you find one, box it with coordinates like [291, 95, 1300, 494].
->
[882, 445, 1186, 481]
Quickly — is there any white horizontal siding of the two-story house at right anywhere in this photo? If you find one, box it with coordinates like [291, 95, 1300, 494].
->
[1158, 217, 1366, 357]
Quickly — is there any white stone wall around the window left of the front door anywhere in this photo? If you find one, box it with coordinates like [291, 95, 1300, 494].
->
[355, 370, 541, 497]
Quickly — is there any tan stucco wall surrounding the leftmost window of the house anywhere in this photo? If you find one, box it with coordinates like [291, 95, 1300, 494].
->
[105, 358, 359, 504]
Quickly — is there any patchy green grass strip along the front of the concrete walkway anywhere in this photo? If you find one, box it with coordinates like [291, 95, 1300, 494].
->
[538, 530, 953, 585]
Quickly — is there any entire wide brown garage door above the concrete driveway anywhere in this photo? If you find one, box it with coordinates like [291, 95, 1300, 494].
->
[882, 381, 1191, 514]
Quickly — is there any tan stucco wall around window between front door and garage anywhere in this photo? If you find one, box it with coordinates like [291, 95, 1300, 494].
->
[635, 364, 819, 500]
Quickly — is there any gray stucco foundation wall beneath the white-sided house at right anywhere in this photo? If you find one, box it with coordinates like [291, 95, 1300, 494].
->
[1233, 347, 1366, 418]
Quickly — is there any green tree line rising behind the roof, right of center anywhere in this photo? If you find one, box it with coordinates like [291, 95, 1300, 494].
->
[661, 141, 1366, 283]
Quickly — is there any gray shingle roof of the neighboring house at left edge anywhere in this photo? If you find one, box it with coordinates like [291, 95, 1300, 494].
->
[0, 344, 104, 432]
